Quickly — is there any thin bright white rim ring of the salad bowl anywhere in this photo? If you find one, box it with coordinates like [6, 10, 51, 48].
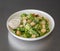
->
[6, 9, 55, 41]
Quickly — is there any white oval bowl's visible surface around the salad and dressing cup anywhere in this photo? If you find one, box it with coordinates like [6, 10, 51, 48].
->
[7, 9, 55, 41]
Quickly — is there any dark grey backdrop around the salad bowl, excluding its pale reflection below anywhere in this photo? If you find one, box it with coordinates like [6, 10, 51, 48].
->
[0, 0, 60, 51]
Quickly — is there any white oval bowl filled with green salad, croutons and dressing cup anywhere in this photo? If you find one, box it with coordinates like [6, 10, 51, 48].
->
[7, 9, 55, 41]
